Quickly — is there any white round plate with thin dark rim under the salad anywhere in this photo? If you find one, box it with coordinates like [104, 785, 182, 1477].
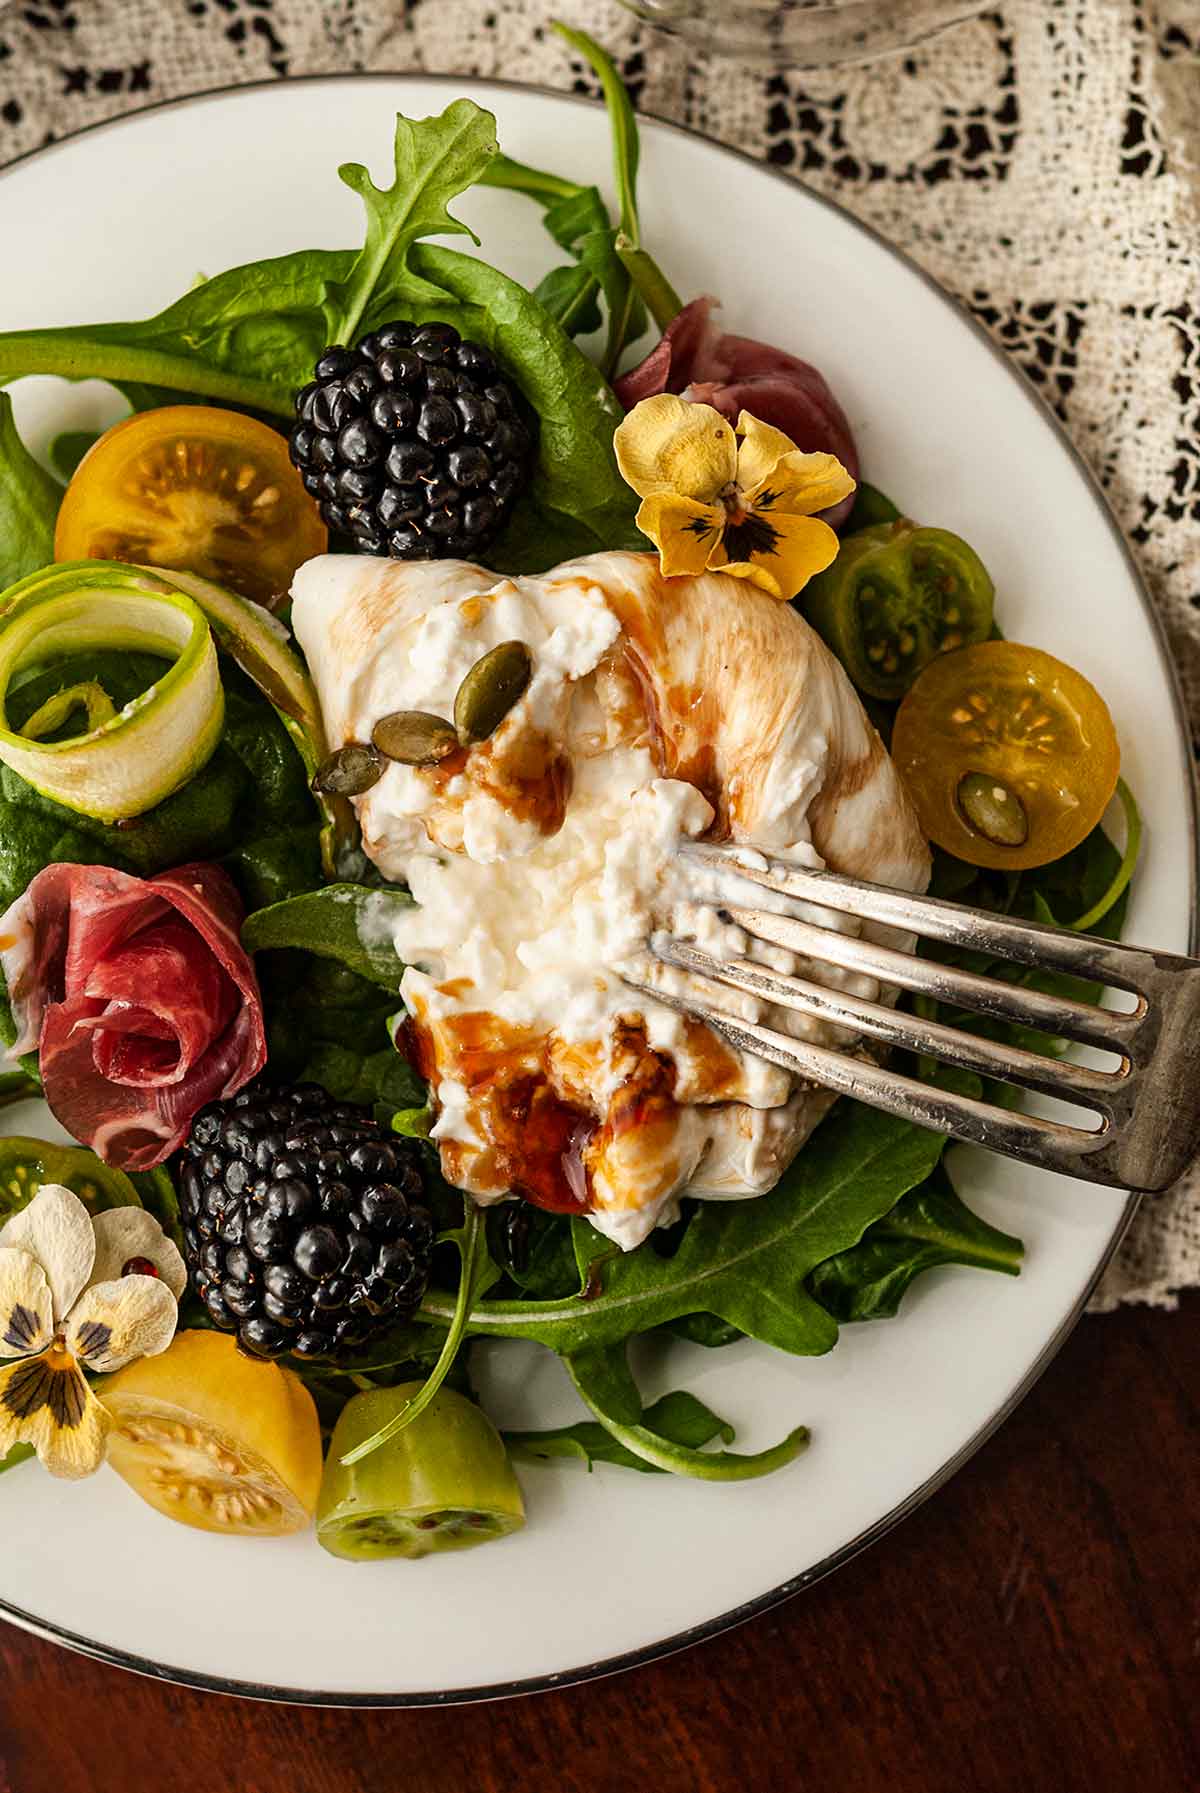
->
[0, 77, 1195, 1703]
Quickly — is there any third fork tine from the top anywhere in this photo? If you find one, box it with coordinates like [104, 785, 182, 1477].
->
[658, 940, 1128, 1115]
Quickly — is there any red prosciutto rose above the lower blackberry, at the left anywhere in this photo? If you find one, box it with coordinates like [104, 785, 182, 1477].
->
[0, 864, 267, 1171]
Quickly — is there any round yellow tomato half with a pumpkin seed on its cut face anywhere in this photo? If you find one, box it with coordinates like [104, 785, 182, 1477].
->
[891, 642, 1121, 871]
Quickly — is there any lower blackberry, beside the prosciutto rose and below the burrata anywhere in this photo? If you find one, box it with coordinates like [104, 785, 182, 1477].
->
[178, 1085, 434, 1359]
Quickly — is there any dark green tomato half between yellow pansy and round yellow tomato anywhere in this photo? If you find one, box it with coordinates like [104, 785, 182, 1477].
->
[800, 518, 996, 701]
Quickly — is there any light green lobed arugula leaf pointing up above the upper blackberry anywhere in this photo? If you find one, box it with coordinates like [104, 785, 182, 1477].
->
[325, 100, 499, 342]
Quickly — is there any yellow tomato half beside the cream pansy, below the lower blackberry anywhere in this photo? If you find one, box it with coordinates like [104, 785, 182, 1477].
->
[99, 1332, 321, 1538]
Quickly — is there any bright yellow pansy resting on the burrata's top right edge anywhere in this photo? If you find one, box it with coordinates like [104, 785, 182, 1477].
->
[613, 393, 854, 599]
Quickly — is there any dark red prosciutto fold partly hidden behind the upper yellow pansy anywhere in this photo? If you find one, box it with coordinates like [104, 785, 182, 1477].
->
[615, 298, 859, 529]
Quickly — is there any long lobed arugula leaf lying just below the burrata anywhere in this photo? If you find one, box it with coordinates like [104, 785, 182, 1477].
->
[420, 1103, 943, 1355]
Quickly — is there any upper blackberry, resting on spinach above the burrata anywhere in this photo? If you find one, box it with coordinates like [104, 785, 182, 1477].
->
[289, 323, 533, 559]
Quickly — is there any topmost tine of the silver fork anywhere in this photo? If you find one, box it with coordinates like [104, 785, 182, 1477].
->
[682, 843, 1159, 993]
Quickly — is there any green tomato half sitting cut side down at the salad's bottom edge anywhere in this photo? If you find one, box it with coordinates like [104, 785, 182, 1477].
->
[317, 1382, 526, 1562]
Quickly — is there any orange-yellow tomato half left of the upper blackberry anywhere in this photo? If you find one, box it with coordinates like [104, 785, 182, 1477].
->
[54, 405, 328, 606]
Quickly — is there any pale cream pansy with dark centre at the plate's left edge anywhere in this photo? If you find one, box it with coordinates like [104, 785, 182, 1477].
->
[0, 1183, 187, 1477]
